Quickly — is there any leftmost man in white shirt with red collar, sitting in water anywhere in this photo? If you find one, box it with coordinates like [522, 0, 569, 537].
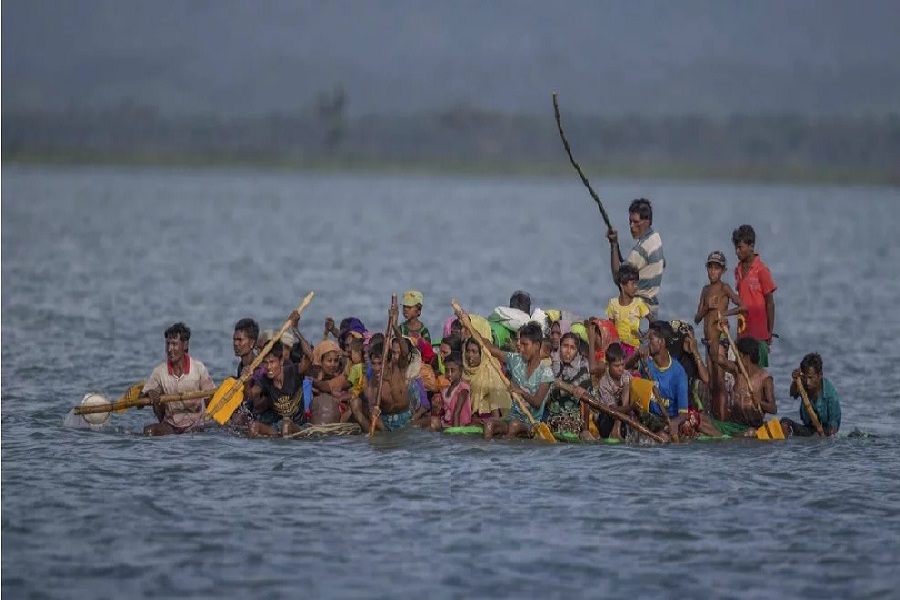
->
[141, 321, 216, 435]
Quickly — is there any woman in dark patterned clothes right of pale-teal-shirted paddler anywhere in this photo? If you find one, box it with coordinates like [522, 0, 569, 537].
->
[547, 331, 594, 439]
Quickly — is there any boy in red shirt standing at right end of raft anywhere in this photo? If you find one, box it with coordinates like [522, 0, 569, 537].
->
[731, 225, 778, 368]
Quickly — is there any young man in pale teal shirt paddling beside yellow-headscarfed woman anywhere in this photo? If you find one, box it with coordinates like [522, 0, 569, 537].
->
[474, 321, 554, 440]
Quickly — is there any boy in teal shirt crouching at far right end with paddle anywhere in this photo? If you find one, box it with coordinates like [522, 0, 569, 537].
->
[781, 353, 841, 436]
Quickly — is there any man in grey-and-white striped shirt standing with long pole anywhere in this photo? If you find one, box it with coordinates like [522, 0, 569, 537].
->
[606, 198, 666, 320]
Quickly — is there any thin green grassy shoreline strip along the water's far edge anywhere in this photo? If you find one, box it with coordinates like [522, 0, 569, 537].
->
[2, 151, 900, 187]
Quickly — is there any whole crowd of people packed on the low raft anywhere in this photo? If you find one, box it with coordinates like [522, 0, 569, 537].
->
[142, 198, 841, 440]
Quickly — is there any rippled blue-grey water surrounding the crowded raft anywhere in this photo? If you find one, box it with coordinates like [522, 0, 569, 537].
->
[2, 167, 900, 598]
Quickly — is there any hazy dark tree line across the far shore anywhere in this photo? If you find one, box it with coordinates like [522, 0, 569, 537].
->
[2, 102, 900, 184]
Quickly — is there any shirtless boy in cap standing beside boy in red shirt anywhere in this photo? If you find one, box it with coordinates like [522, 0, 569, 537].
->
[694, 250, 747, 421]
